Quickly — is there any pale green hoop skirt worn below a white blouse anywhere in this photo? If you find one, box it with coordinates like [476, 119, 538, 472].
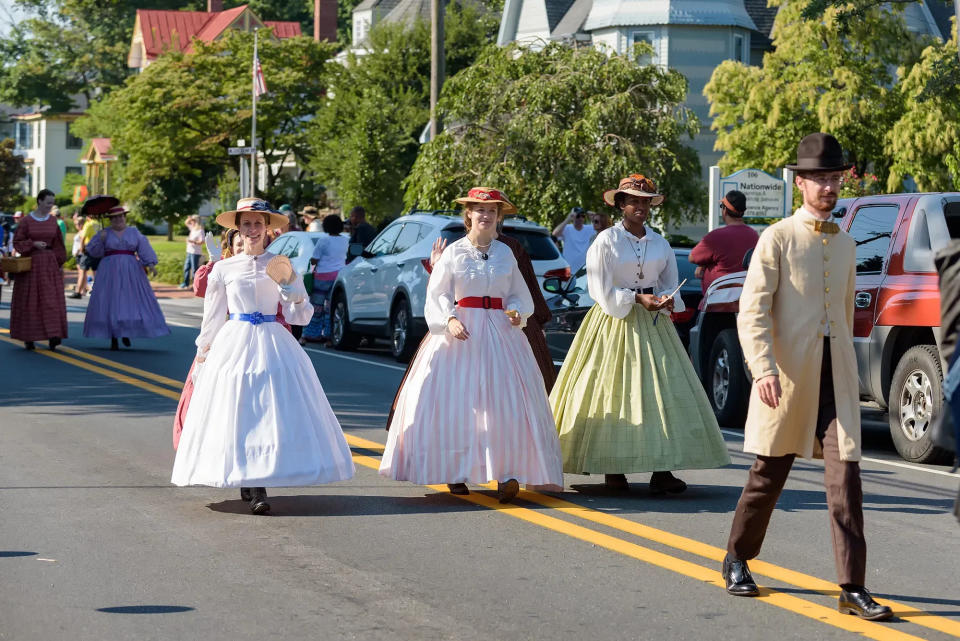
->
[550, 305, 730, 474]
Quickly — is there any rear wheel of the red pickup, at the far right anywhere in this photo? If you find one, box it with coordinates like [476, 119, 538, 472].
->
[887, 345, 950, 463]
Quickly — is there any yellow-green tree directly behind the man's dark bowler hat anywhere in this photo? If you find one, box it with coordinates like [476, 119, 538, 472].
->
[704, 0, 923, 182]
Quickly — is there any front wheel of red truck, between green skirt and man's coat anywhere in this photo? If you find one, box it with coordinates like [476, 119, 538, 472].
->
[705, 329, 750, 427]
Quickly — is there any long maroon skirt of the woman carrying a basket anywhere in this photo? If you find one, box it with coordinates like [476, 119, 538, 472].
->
[10, 251, 67, 341]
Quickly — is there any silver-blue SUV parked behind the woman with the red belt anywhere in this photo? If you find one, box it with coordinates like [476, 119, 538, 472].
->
[331, 211, 570, 362]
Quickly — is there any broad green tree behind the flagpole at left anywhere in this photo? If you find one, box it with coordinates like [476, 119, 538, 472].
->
[75, 32, 333, 235]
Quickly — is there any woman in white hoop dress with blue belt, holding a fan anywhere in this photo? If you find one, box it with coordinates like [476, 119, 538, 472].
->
[171, 198, 354, 514]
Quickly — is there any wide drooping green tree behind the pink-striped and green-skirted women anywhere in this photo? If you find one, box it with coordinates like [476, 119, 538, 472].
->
[405, 43, 705, 225]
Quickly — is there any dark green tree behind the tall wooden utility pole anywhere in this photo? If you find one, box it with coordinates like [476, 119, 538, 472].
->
[310, 3, 499, 221]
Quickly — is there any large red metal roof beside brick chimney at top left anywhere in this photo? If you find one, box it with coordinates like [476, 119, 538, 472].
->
[137, 5, 301, 60]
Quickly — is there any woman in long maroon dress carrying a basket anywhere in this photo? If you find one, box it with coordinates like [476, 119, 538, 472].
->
[10, 189, 67, 349]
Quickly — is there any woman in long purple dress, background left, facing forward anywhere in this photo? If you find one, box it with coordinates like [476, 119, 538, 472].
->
[83, 207, 170, 350]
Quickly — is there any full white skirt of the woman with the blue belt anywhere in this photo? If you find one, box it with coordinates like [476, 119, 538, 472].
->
[171, 320, 354, 487]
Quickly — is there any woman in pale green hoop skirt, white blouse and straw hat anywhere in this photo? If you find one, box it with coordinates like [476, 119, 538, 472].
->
[550, 174, 730, 494]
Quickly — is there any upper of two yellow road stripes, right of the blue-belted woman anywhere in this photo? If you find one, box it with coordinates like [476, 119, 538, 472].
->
[347, 434, 960, 637]
